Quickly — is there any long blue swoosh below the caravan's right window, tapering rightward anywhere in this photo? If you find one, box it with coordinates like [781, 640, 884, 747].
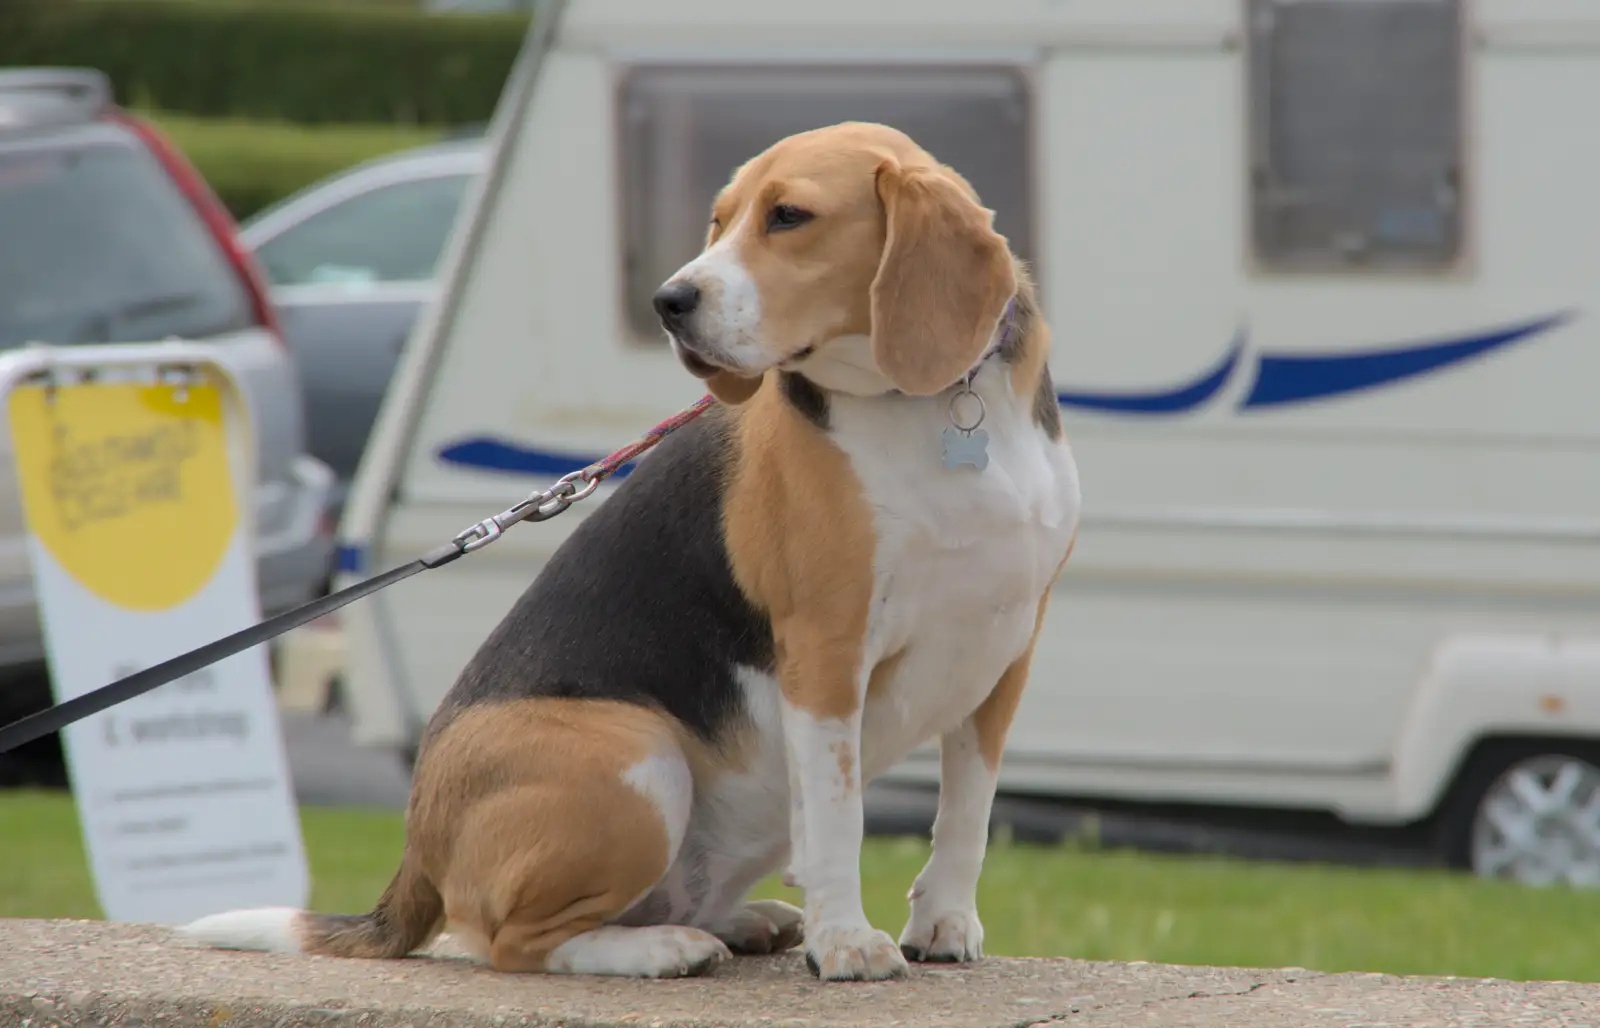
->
[1240, 312, 1571, 410]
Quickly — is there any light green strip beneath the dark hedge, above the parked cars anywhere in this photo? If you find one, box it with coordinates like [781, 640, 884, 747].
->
[144, 111, 442, 221]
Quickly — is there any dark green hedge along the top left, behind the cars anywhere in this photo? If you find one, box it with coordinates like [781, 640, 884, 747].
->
[0, 0, 528, 125]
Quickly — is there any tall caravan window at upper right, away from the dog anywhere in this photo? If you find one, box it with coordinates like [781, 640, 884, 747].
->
[1248, 0, 1464, 269]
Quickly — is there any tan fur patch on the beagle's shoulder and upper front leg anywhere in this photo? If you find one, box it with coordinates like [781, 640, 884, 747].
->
[723, 381, 875, 717]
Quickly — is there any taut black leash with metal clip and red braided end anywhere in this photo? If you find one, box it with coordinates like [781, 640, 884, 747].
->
[0, 397, 714, 753]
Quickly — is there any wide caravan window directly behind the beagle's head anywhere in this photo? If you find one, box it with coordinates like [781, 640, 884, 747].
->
[619, 66, 1035, 341]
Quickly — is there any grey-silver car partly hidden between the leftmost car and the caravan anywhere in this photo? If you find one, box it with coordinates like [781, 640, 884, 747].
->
[240, 138, 488, 508]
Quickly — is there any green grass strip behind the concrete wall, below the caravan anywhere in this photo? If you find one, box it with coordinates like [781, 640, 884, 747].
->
[0, 791, 1600, 982]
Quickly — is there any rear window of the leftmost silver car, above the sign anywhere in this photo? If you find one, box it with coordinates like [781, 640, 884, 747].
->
[0, 143, 254, 347]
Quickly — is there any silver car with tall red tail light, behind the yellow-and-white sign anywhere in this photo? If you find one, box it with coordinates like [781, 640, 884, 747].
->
[0, 69, 333, 742]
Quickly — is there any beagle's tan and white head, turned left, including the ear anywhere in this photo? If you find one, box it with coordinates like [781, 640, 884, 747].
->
[654, 122, 1016, 404]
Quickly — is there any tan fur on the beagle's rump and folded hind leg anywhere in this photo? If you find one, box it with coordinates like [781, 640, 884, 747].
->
[310, 698, 680, 970]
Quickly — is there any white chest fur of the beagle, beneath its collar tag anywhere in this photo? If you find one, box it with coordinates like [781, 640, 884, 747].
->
[830, 360, 1080, 777]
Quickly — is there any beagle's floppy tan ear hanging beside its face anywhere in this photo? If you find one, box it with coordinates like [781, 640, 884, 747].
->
[872, 159, 1016, 396]
